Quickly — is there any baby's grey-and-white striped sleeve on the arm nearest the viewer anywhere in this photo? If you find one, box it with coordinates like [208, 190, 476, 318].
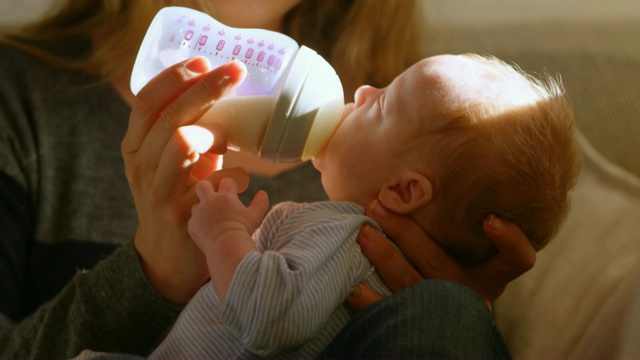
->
[220, 203, 373, 356]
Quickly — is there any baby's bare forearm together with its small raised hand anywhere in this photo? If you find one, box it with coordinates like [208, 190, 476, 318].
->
[188, 178, 269, 302]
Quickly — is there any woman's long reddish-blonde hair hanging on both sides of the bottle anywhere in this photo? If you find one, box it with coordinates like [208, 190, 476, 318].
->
[2, 0, 424, 99]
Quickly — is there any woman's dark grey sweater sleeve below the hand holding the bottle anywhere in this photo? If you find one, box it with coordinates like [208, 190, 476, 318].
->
[0, 243, 180, 359]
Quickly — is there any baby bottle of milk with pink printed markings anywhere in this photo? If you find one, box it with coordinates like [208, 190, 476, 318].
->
[131, 7, 344, 162]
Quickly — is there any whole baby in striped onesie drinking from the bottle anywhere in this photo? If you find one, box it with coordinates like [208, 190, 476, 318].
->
[152, 55, 579, 358]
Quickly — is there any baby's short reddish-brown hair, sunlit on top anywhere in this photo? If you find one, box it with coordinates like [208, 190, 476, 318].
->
[422, 55, 580, 260]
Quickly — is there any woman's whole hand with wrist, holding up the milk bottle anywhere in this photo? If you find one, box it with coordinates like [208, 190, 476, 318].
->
[121, 57, 248, 304]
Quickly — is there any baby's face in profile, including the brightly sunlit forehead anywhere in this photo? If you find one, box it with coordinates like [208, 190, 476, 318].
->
[313, 55, 528, 205]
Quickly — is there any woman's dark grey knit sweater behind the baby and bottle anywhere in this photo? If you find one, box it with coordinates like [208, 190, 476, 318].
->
[0, 38, 326, 358]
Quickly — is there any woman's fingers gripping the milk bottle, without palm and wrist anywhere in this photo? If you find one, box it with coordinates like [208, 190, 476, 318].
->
[122, 57, 246, 181]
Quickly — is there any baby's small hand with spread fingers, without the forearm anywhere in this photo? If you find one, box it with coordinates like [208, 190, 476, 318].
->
[188, 178, 269, 254]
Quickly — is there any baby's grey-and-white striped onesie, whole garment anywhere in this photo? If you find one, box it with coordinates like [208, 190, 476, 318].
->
[151, 201, 390, 359]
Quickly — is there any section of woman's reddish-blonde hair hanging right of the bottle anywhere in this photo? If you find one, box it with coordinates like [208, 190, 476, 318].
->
[286, 0, 425, 98]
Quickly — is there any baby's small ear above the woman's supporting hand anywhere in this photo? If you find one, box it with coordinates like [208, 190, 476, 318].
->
[378, 171, 433, 214]
